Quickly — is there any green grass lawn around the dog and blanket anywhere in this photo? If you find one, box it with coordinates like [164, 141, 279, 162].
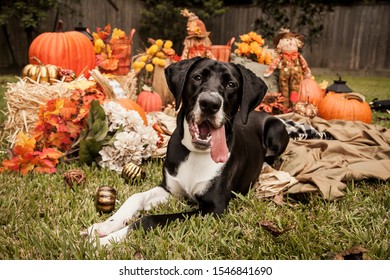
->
[0, 72, 390, 260]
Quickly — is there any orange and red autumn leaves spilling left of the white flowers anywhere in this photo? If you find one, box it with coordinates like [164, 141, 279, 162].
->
[0, 88, 105, 175]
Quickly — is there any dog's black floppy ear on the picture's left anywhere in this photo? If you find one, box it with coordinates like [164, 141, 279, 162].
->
[165, 57, 202, 110]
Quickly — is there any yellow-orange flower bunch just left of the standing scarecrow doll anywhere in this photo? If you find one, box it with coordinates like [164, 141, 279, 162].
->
[234, 31, 274, 65]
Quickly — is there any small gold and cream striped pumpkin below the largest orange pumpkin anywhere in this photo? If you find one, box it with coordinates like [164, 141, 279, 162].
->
[22, 56, 58, 84]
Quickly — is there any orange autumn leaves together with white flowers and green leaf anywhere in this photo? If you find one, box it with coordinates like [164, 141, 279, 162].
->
[0, 82, 161, 175]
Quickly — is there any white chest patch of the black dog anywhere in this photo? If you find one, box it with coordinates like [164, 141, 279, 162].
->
[165, 152, 225, 201]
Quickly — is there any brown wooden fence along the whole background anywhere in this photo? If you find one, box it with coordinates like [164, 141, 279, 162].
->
[0, 0, 390, 76]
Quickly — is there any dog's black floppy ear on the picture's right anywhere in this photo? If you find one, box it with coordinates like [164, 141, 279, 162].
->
[235, 64, 268, 124]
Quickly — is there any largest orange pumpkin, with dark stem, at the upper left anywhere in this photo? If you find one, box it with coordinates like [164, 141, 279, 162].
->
[29, 22, 96, 78]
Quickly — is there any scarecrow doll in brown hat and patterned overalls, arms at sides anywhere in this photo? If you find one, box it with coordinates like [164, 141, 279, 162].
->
[264, 28, 312, 108]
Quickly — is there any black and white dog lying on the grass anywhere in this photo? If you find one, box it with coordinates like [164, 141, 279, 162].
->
[87, 58, 289, 245]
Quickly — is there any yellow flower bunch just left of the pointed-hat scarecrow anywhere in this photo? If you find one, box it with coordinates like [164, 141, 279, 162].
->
[132, 39, 179, 88]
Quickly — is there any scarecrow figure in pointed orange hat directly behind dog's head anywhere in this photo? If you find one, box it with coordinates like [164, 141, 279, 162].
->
[181, 9, 215, 59]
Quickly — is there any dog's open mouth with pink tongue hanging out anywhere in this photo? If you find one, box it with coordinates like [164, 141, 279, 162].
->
[189, 121, 229, 163]
